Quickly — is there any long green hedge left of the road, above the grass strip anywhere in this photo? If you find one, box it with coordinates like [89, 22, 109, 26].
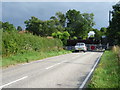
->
[2, 32, 62, 56]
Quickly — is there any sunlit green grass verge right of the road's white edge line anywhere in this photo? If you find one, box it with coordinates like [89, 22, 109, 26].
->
[88, 50, 120, 88]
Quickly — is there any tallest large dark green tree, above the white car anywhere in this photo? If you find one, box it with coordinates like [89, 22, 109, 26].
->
[66, 9, 94, 38]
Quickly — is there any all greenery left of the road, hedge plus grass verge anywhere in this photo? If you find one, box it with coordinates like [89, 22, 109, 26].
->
[0, 31, 70, 67]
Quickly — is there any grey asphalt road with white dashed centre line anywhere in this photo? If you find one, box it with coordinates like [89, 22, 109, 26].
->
[0, 52, 102, 88]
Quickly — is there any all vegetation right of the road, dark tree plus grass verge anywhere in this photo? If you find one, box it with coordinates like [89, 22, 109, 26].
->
[88, 3, 120, 88]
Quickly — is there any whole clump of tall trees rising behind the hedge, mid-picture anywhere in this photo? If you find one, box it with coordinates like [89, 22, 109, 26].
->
[25, 9, 94, 38]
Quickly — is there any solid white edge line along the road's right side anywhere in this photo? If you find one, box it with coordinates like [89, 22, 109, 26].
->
[79, 53, 103, 88]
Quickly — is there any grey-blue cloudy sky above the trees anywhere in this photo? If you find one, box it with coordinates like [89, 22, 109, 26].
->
[2, 2, 116, 29]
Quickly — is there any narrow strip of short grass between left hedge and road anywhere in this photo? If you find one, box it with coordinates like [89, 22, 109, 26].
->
[0, 50, 71, 67]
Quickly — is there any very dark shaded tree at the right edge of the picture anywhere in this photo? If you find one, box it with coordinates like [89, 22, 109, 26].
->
[107, 3, 120, 45]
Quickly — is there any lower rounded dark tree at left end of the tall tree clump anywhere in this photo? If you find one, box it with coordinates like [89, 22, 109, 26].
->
[24, 16, 52, 36]
